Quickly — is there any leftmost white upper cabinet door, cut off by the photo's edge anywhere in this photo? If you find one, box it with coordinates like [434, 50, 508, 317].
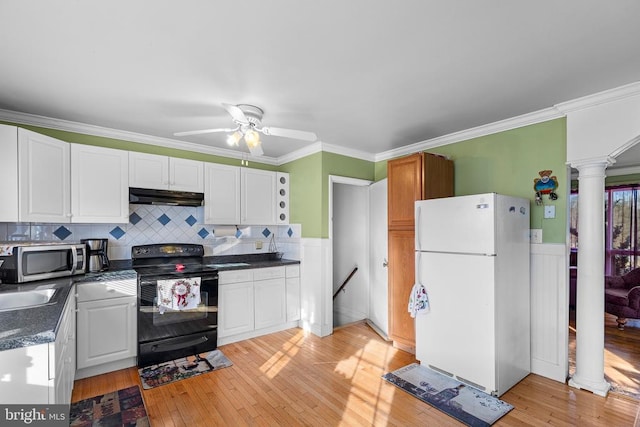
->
[0, 125, 19, 222]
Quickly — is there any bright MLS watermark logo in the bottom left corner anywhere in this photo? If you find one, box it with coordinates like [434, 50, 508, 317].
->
[0, 405, 69, 427]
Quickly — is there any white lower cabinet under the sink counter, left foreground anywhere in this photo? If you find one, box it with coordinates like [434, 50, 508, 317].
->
[0, 293, 76, 405]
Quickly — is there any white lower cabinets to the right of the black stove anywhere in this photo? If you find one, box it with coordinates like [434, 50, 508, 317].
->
[218, 266, 300, 345]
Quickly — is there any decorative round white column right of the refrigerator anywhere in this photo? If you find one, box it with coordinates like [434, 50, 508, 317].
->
[569, 157, 614, 396]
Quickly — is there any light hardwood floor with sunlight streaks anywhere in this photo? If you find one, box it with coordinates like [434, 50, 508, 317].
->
[73, 323, 640, 427]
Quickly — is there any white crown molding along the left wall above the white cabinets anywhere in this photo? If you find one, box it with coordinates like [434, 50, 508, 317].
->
[0, 109, 278, 165]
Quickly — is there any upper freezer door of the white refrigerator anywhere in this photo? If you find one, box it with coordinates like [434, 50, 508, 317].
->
[415, 193, 496, 254]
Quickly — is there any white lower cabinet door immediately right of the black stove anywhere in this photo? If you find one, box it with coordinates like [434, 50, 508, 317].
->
[218, 282, 254, 338]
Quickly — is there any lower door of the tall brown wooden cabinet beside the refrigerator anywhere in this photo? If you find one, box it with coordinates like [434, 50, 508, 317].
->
[389, 230, 415, 351]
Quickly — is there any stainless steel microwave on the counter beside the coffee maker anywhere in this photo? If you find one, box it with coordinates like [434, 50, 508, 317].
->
[0, 241, 87, 283]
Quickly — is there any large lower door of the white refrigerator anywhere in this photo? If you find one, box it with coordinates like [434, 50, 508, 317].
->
[416, 252, 496, 393]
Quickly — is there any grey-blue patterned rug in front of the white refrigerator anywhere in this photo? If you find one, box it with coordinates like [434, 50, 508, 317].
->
[382, 363, 513, 427]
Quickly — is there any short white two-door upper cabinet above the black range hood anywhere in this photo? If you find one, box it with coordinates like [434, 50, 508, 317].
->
[129, 152, 204, 193]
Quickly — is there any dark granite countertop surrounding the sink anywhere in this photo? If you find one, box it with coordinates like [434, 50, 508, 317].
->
[0, 277, 73, 351]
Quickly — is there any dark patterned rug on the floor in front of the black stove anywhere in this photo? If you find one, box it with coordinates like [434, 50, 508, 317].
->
[138, 350, 233, 390]
